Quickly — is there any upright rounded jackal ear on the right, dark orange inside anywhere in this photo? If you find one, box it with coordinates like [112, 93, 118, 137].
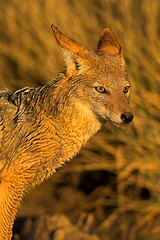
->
[97, 28, 121, 54]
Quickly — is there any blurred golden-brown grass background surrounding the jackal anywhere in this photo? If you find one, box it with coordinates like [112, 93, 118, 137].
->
[0, 0, 160, 240]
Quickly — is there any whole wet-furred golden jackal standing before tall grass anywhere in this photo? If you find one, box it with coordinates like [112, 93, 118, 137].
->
[0, 25, 133, 240]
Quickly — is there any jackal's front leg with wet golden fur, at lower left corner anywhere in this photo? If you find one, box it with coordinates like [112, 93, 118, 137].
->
[0, 176, 26, 240]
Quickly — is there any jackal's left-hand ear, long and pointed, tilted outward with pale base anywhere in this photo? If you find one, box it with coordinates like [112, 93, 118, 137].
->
[51, 24, 91, 70]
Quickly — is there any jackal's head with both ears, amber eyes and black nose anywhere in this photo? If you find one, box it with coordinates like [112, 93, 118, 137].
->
[52, 25, 133, 126]
